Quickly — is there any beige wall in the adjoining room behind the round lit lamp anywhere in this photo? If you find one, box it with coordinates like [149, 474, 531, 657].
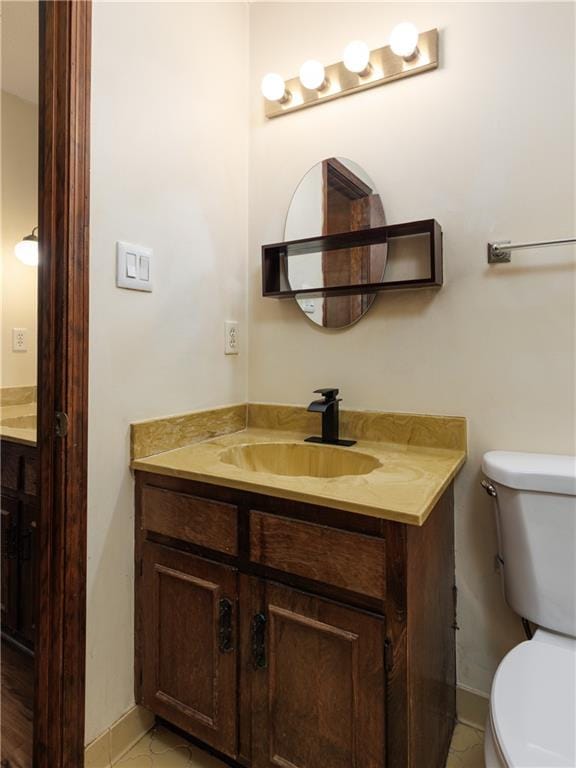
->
[0, 91, 38, 387]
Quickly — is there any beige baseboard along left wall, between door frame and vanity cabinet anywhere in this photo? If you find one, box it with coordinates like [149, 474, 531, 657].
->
[84, 706, 154, 768]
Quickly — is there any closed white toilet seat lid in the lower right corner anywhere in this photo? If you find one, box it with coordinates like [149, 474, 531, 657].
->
[490, 630, 576, 768]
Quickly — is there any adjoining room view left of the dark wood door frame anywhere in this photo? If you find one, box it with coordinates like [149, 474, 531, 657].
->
[0, 1, 39, 768]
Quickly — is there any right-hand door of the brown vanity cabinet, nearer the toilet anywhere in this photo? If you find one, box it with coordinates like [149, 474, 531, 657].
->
[252, 583, 385, 768]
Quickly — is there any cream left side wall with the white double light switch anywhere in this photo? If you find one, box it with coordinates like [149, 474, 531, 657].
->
[86, 2, 248, 741]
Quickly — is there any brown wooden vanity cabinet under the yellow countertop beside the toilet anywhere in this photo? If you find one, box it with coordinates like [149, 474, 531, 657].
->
[136, 472, 455, 768]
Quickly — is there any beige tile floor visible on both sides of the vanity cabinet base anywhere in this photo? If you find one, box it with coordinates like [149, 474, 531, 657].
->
[115, 724, 484, 768]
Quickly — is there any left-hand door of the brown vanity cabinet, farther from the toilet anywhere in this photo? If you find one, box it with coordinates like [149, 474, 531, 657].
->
[139, 542, 237, 757]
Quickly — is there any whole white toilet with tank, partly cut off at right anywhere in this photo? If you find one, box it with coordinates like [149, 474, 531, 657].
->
[482, 451, 576, 768]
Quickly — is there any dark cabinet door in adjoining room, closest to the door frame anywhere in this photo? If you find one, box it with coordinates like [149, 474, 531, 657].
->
[18, 503, 38, 648]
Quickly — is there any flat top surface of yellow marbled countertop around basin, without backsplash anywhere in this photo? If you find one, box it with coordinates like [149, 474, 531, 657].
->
[131, 417, 466, 525]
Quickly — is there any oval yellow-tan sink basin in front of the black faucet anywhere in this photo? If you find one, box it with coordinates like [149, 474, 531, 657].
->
[220, 443, 382, 477]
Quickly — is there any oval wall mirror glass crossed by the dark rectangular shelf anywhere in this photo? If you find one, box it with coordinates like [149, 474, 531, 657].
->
[284, 157, 387, 328]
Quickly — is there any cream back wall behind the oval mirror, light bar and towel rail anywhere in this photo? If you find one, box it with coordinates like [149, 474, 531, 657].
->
[249, 3, 576, 692]
